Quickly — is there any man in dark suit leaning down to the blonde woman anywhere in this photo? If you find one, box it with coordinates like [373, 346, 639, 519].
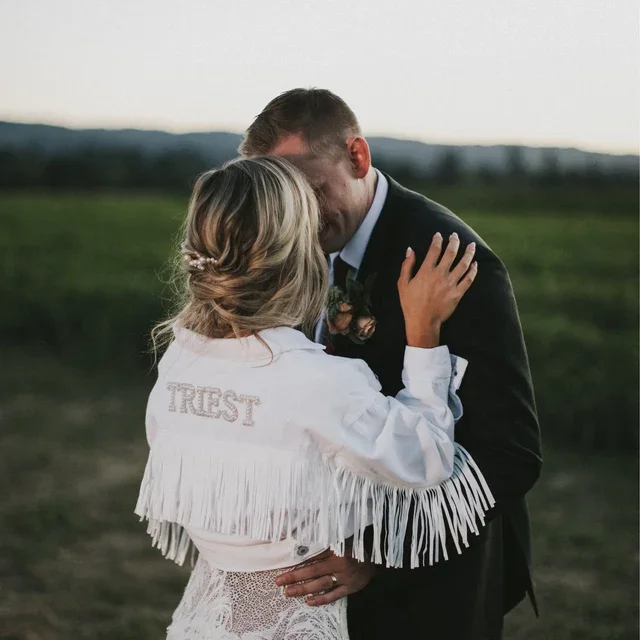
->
[240, 89, 541, 640]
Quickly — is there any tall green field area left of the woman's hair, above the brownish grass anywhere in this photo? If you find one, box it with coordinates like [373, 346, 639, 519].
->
[0, 190, 186, 362]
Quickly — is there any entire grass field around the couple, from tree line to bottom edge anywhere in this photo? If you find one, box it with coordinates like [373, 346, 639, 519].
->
[0, 190, 638, 640]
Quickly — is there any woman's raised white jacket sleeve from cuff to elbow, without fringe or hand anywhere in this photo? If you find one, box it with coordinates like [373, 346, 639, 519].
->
[333, 347, 466, 488]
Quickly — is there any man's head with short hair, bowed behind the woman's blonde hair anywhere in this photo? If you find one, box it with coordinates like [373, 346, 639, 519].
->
[240, 89, 375, 253]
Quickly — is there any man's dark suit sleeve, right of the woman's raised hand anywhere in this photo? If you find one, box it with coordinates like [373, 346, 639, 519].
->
[442, 249, 542, 508]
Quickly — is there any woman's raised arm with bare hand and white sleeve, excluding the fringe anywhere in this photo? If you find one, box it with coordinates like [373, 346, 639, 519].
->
[320, 234, 477, 488]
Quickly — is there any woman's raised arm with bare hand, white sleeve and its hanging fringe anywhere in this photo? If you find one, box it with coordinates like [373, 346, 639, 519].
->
[298, 237, 493, 567]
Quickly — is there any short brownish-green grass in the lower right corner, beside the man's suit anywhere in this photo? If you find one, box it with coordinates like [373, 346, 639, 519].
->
[505, 448, 638, 640]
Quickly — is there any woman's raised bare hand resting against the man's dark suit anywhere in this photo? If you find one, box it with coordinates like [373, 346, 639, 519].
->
[398, 233, 478, 348]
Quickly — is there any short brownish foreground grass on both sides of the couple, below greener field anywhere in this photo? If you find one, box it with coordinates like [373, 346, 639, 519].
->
[0, 350, 638, 640]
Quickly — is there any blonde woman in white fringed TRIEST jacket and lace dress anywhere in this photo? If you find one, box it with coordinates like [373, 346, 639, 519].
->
[135, 152, 493, 640]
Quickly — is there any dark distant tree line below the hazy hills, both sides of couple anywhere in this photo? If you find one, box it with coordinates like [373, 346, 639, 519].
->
[0, 147, 638, 192]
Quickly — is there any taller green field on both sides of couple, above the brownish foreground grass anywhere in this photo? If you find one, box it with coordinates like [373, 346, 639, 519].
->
[0, 188, 638, 450]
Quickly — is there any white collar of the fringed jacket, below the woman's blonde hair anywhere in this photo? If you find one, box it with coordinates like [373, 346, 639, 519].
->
[173, 325, 325, 361]
